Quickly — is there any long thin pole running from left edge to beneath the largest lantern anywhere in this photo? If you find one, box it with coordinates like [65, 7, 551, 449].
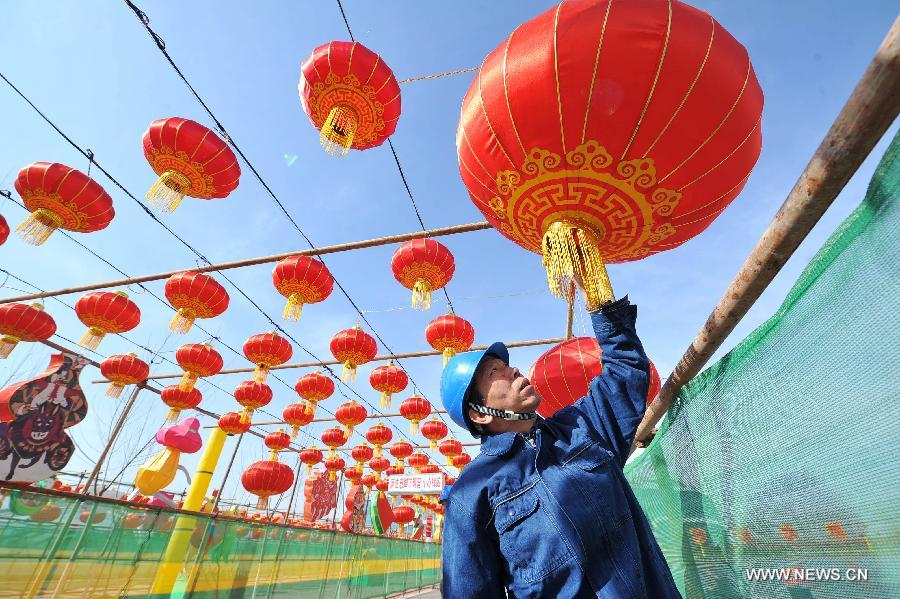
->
[0, 221, 491, 305]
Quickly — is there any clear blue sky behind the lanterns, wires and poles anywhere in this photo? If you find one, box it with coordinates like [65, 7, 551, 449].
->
[0, 0, 896, 510]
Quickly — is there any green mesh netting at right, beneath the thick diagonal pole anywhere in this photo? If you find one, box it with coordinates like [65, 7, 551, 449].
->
[626, 131, 900, 599]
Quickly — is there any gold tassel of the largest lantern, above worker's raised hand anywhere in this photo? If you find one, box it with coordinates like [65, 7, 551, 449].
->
[542, 221, 615, 310]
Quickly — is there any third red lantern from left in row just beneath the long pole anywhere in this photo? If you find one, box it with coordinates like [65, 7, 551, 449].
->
[165, 272, 229, 334]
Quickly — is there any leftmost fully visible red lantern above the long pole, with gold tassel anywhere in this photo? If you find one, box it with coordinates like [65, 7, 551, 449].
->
[16, 162, 116, 245]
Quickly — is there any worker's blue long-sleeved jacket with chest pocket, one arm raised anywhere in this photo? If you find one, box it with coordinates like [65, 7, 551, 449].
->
[442, 297, 680, 599]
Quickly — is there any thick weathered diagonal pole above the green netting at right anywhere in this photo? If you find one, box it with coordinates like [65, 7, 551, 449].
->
[632, 17, 900, 449]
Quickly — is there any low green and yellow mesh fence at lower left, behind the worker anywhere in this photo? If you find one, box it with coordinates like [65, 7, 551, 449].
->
[0, 491, 441, 599]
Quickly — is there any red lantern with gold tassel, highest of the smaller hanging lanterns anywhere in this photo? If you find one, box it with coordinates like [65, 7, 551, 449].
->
[299, 42, 400, 156]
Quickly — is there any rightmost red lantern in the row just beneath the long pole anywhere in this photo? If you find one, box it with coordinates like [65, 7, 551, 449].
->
[391, 239, 456, 310]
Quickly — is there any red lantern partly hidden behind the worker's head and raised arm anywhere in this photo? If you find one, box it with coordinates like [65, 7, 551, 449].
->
[528, 337, 660, 418]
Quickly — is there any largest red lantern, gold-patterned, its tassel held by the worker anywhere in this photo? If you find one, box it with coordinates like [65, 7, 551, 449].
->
[456, 0, 763, 306]
